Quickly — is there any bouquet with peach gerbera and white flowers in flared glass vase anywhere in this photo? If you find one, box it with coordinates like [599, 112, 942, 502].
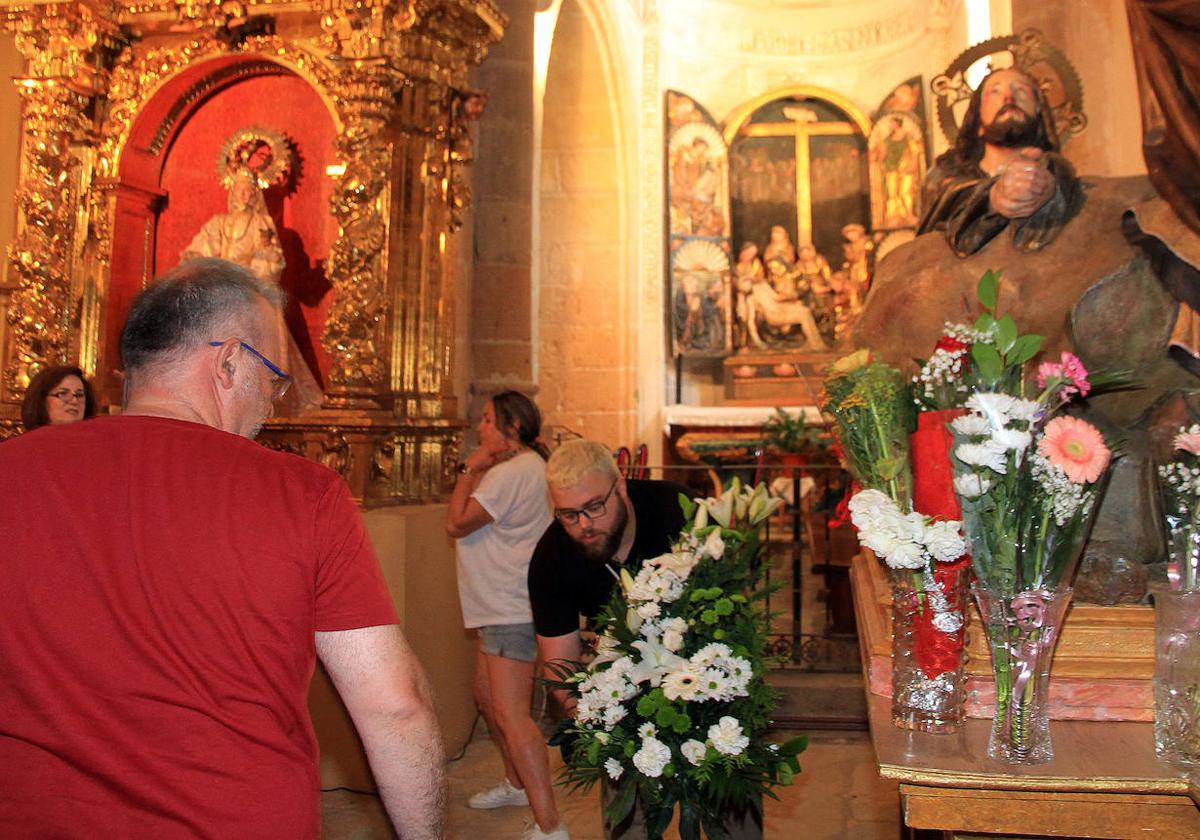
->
[950, 271, 1123, 764]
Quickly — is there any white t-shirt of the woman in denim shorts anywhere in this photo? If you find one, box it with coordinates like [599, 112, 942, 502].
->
[457, 451, 553, 628]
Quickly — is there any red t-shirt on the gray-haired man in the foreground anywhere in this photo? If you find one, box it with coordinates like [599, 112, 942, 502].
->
[0, 416, 396, 840]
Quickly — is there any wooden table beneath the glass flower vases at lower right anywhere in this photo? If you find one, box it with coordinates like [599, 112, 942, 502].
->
[868, 695, 1200, 840]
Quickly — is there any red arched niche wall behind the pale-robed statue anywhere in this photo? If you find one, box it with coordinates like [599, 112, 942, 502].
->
[106, 61, 337, 396]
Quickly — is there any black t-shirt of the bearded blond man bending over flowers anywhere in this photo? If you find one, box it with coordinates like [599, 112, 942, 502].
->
[529, 479, 691, 636]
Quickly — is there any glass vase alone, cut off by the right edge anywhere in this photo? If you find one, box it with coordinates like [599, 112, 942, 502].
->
[1153, 587, 1200, 767]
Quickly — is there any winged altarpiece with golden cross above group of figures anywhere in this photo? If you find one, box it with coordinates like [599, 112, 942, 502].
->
[666, 77, 929, 356]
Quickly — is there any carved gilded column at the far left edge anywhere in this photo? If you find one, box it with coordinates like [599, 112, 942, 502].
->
[0, 2, 116, 402]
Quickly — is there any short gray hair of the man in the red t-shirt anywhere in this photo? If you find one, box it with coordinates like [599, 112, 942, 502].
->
[121, 257, 283, 374]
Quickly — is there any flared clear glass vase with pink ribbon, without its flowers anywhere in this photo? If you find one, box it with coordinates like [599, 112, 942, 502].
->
[972, 582, 1072, 764]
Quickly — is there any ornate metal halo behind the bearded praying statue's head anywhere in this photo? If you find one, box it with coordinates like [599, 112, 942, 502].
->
[930, 29, 1087, 146]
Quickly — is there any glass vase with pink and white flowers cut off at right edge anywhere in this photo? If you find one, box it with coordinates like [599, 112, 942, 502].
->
[1153, 425, 1200, 766]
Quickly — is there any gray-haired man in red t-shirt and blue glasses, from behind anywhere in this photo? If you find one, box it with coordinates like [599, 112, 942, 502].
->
[0, 259, 445, 840]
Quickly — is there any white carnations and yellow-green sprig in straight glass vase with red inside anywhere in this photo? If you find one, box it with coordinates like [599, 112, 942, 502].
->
[823, 352, 966, 733]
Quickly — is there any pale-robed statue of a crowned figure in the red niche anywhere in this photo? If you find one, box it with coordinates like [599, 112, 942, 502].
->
[180, 167, 323, 416]
